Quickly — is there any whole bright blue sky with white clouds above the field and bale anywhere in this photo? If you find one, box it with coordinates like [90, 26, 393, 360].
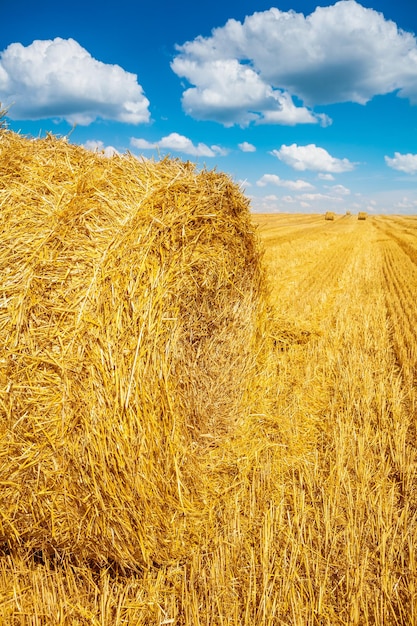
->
[0, 0, 417, 214]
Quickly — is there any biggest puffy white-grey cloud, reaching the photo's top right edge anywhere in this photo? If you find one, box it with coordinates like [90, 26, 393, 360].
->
[171, 0, 417, 126]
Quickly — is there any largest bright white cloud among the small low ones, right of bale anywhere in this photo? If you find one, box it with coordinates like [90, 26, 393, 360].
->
[271, 143, 355, 174]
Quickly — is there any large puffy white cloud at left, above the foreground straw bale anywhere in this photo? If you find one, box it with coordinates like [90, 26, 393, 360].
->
[0, 37, 150, 125]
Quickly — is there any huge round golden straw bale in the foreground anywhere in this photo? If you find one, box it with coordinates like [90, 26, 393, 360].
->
[0, 128, 264, 567]
